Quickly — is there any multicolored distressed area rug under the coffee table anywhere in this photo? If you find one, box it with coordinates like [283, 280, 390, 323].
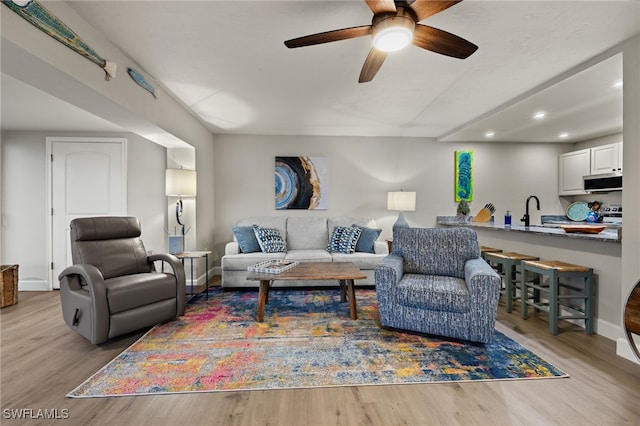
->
[67, 289, 568, 398]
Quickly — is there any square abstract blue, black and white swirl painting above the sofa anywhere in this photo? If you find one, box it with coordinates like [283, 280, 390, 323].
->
[275, 157, 329, 210]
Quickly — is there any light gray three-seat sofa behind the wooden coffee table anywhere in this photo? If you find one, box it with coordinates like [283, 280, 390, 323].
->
[221, 216, 389, 288]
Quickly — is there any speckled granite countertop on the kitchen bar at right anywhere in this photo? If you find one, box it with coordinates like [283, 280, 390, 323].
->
[436, 216, 622, 243]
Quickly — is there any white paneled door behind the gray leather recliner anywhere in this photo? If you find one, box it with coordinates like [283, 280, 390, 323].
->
[47, 138, 126, 288]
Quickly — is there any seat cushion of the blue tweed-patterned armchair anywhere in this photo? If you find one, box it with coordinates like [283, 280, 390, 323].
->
[397, 274, 471, 312]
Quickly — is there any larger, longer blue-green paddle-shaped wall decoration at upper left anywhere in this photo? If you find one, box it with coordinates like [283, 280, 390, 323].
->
[2, 0, 117, 80]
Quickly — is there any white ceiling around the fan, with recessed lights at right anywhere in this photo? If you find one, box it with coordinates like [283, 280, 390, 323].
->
[2, 0, 640, 142]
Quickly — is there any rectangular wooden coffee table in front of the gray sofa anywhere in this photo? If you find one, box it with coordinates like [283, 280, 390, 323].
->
[247, 262, 366, 322]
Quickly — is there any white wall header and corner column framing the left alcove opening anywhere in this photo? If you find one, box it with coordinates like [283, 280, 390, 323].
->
[0, 2, 214, 284]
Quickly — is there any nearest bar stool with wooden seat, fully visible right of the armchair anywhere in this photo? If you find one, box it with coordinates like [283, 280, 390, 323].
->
[520, 260, 594, 335]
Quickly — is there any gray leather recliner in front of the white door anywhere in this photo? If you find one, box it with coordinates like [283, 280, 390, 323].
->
[58, 216, 186, 344]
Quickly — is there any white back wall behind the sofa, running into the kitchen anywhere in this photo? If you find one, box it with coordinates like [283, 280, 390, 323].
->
[214, 135, 569, 261]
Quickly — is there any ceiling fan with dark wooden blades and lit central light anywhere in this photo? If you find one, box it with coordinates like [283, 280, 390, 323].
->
[284, 0, 478, 83]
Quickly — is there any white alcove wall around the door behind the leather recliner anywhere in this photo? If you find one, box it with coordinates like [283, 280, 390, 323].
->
[0, 131, 167, 290]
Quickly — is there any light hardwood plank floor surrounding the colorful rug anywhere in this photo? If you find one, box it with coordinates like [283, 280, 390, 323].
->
[0, 280, 640, 425]
